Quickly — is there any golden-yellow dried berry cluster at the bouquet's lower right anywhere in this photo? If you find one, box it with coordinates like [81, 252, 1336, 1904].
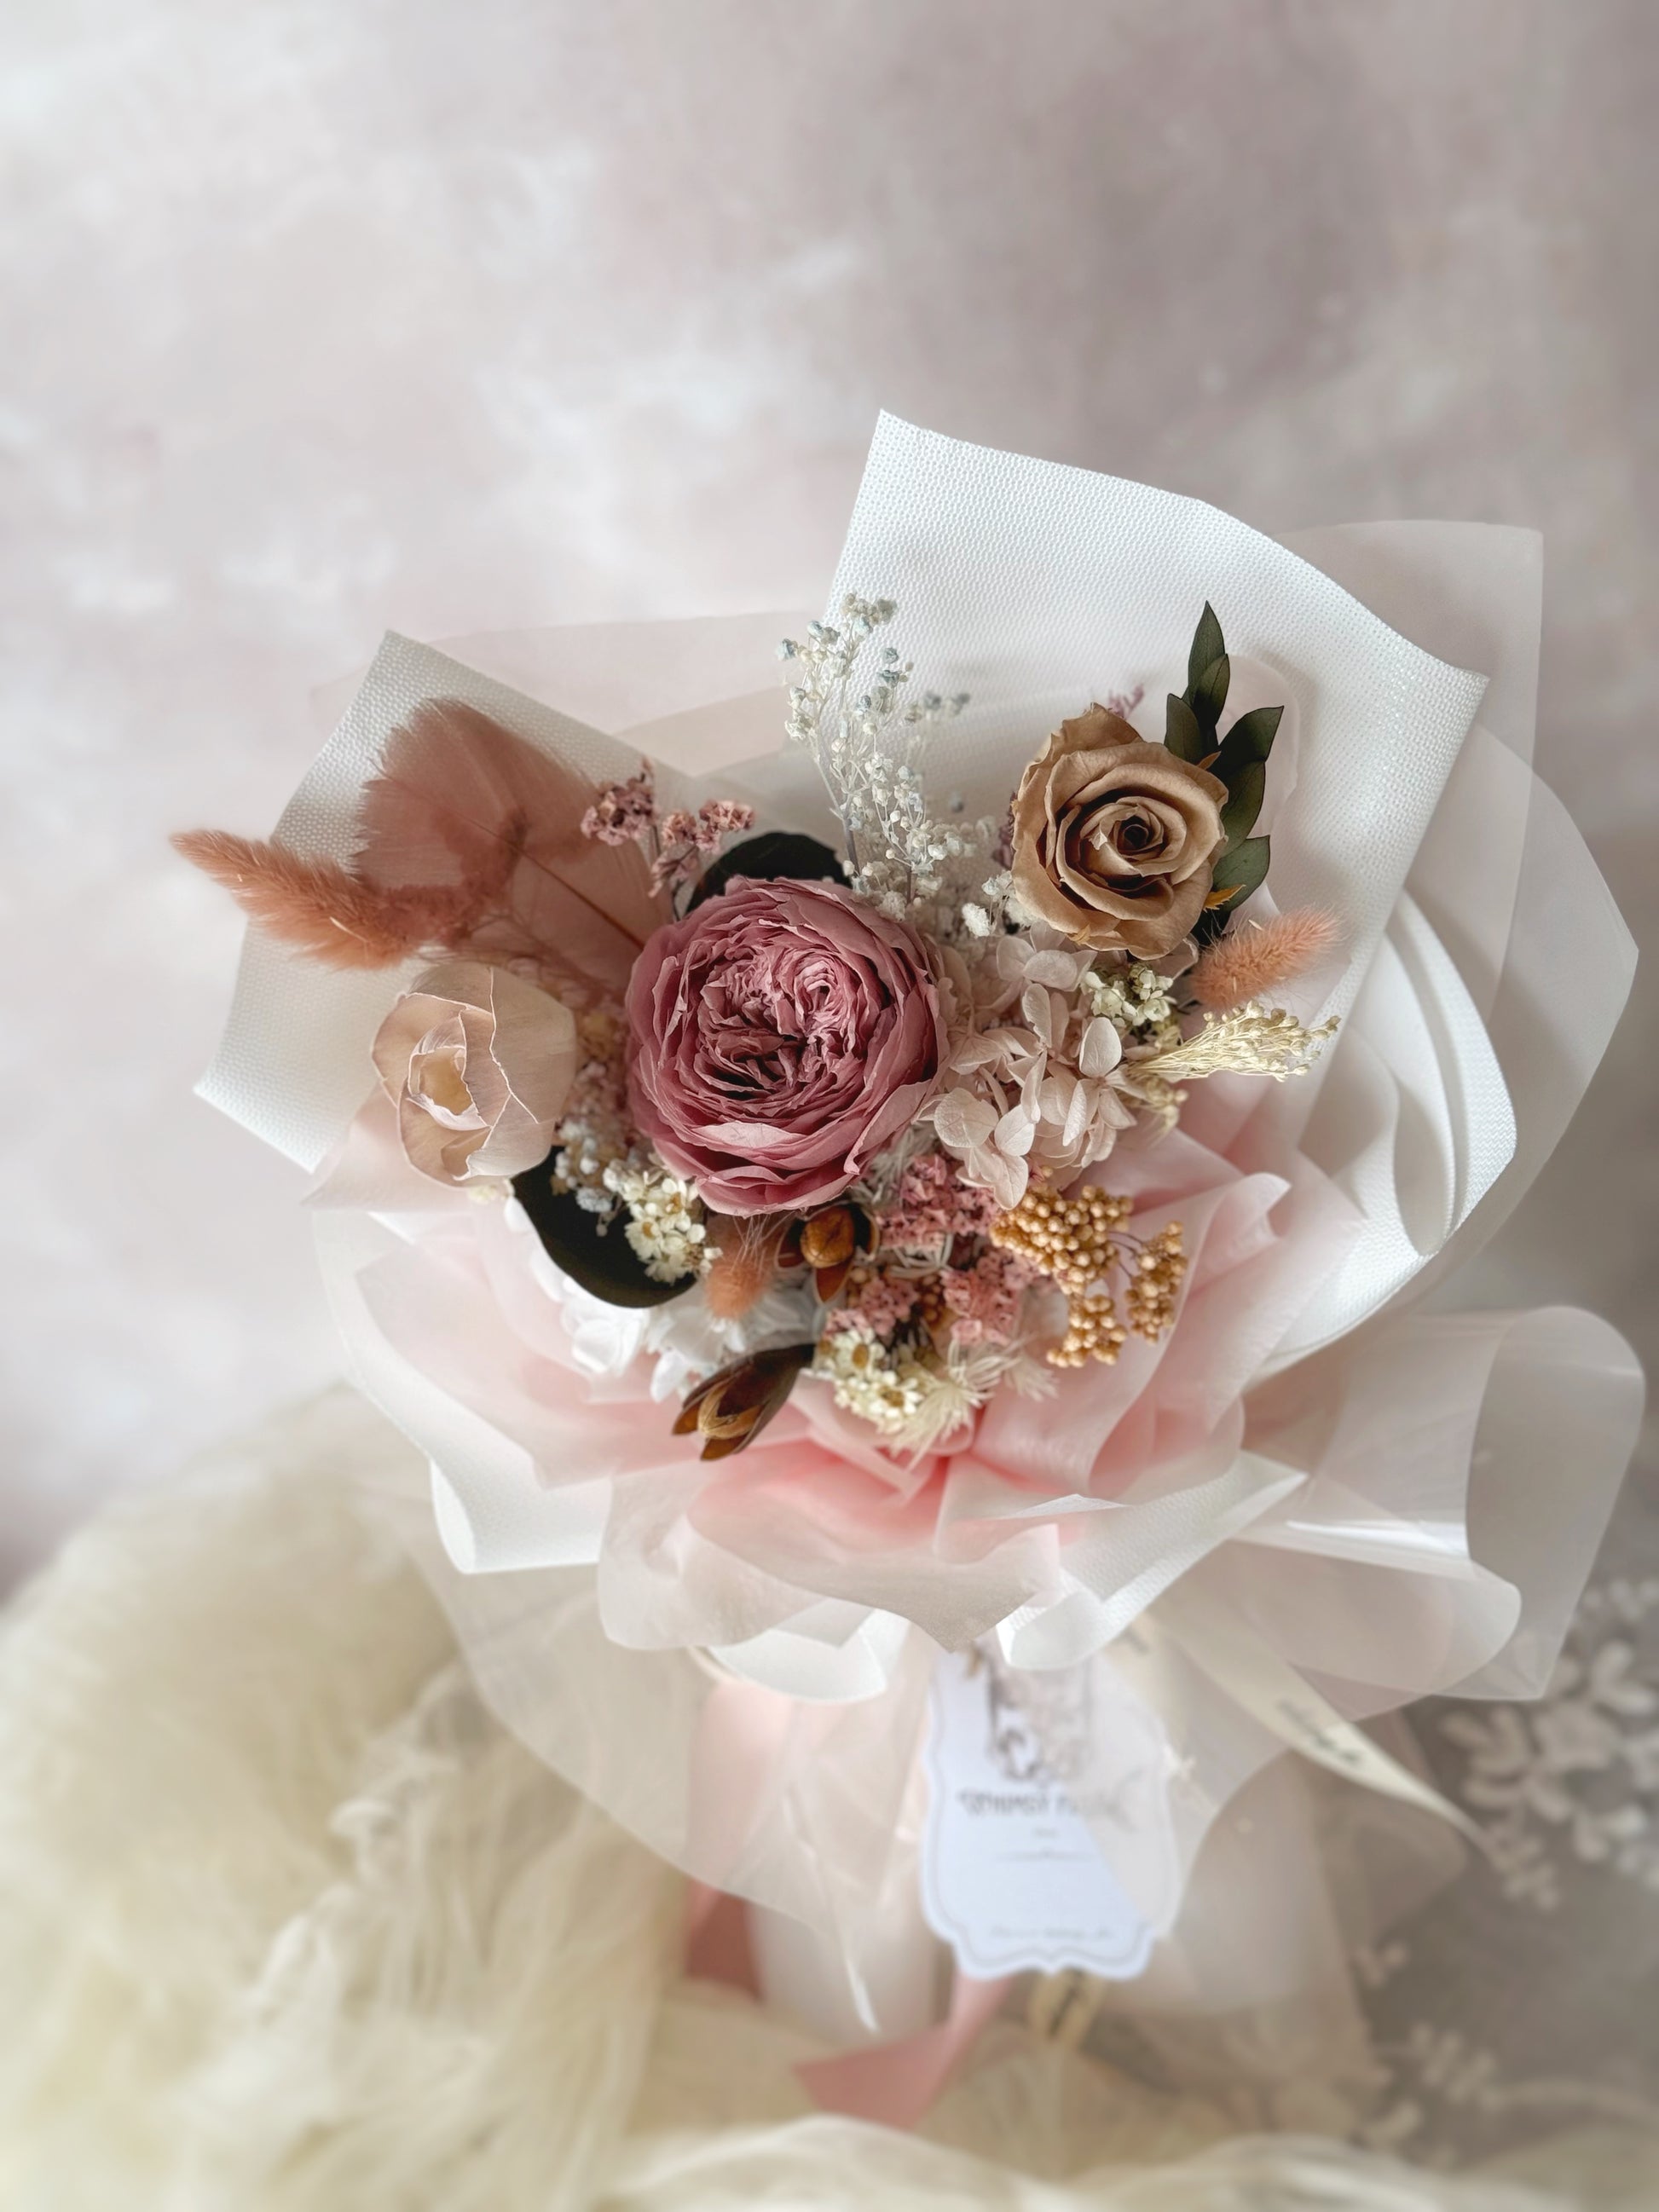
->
[991, 1188, 1186, 1367]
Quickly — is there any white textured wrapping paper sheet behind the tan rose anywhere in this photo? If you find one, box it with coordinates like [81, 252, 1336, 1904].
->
[832, 416, 1487, 960]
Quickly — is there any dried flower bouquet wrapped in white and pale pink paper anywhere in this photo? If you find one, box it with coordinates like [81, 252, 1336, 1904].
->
[179, 418, 1639, 2088]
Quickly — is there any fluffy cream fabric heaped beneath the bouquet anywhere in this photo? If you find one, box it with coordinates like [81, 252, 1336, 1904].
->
[0, 1394, 1659, 2212]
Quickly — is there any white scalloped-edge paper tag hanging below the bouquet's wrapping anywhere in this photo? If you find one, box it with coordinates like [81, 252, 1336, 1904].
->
[922, 1650, 1175, 1982]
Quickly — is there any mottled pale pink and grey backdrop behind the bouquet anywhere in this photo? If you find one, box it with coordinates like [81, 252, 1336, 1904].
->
[0, 0, 1659, 1568]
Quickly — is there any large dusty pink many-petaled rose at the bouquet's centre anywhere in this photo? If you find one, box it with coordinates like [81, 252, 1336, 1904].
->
[628, 876, 947, 1215]
